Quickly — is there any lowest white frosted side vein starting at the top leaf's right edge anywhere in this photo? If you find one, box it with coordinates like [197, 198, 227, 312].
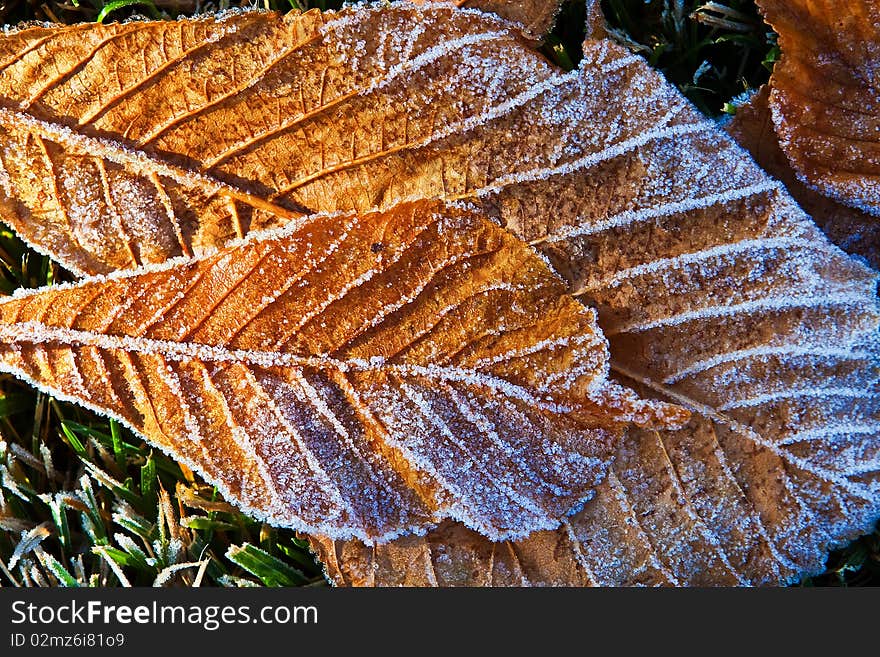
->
[605, 293, 867, 337]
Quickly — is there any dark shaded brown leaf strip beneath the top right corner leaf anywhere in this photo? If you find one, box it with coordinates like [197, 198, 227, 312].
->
[726, 85, 880, 269]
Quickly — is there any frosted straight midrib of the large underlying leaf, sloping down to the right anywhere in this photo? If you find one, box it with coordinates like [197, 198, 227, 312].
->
[611, 363, 873, 500]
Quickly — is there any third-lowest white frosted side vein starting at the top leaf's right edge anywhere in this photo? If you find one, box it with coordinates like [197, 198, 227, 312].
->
[544, 180, 781, 244]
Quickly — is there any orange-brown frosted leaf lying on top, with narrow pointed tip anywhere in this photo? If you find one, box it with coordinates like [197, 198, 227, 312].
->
[0, 197, 684, 539]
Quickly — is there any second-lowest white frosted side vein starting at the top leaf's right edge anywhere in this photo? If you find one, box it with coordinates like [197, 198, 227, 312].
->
[578, 237, 831, 294]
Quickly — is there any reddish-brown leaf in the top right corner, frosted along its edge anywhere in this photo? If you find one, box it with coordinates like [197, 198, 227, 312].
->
[758, 0, 880, 216]
